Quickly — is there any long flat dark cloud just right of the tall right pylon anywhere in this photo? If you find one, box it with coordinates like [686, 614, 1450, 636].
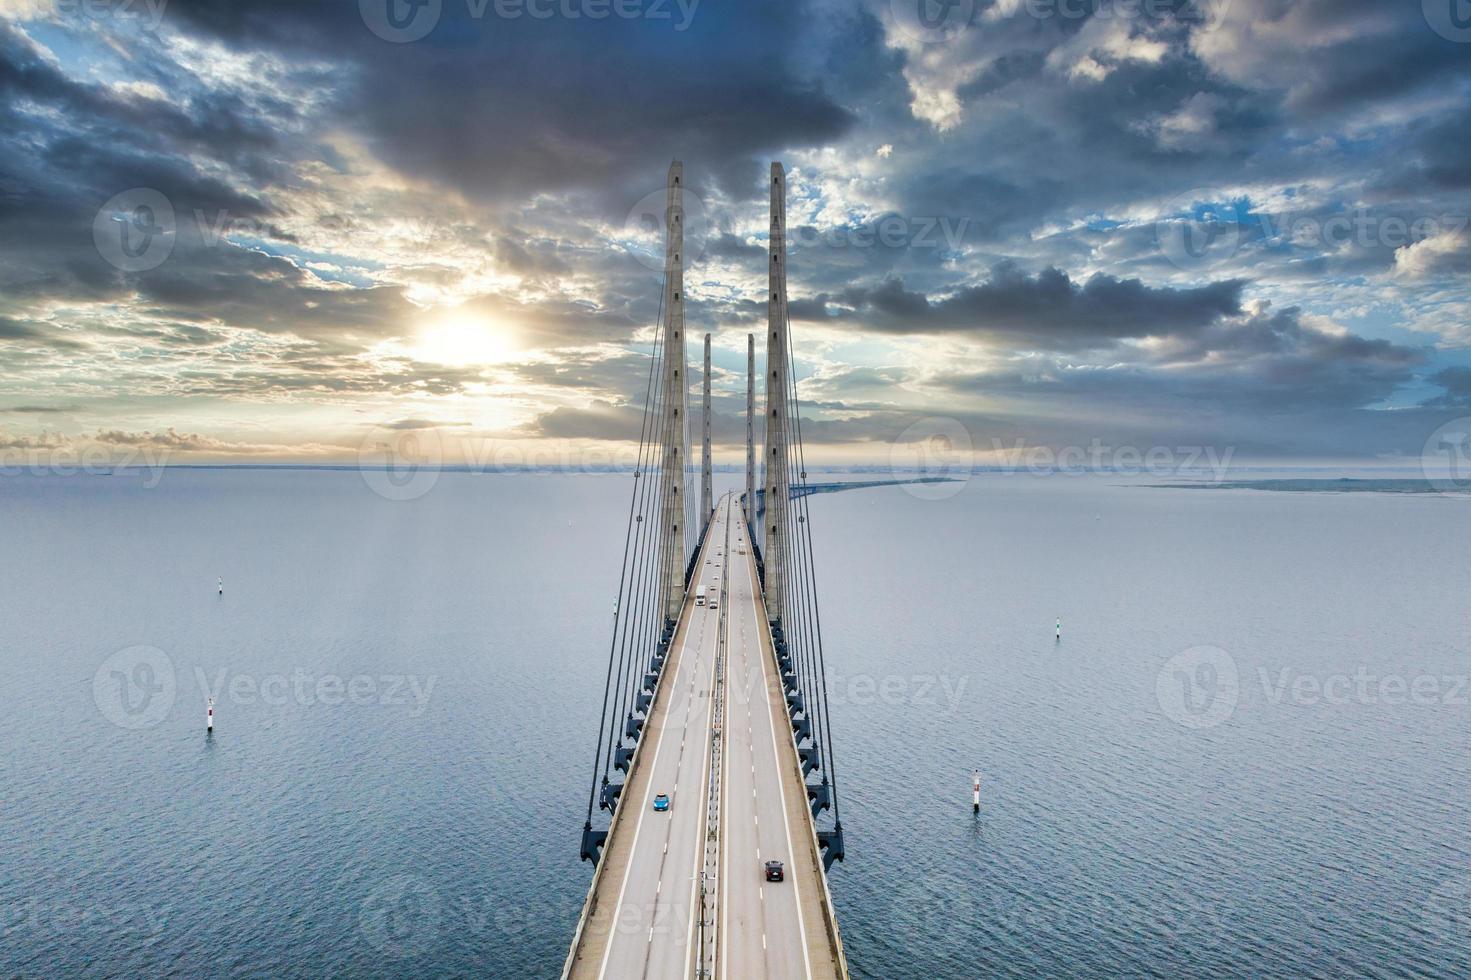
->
[793, 265, 1244, 350]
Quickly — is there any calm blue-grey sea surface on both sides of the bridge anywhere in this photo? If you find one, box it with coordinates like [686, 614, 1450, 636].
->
[0, 469, 1471, 980]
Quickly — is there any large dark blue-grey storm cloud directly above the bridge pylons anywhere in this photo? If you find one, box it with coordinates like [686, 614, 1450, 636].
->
[159, 0, 859, 206]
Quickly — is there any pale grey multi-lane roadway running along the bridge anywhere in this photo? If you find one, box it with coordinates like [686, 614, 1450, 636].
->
[563, 494, 846, 980]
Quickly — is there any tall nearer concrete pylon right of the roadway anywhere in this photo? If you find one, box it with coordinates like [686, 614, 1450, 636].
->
[762, 163, 787, 622]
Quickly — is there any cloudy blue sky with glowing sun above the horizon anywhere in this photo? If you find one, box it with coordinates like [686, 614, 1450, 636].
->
[0, 0, 1471, 466]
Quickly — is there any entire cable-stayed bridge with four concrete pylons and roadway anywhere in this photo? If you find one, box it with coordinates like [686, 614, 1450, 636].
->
[563, 162, 847, 980]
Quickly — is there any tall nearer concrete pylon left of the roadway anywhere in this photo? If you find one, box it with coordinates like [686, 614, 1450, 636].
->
[659, 160, 688, 621]
